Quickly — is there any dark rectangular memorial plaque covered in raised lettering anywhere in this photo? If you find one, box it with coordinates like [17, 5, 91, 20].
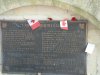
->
[1, 20, 87, 75]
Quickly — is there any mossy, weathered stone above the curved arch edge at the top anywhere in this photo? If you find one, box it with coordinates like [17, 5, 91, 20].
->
[0, 0, 100, 28]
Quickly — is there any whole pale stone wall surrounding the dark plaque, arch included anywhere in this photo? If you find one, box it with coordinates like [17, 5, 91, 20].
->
[0, 0, 100, 75]
